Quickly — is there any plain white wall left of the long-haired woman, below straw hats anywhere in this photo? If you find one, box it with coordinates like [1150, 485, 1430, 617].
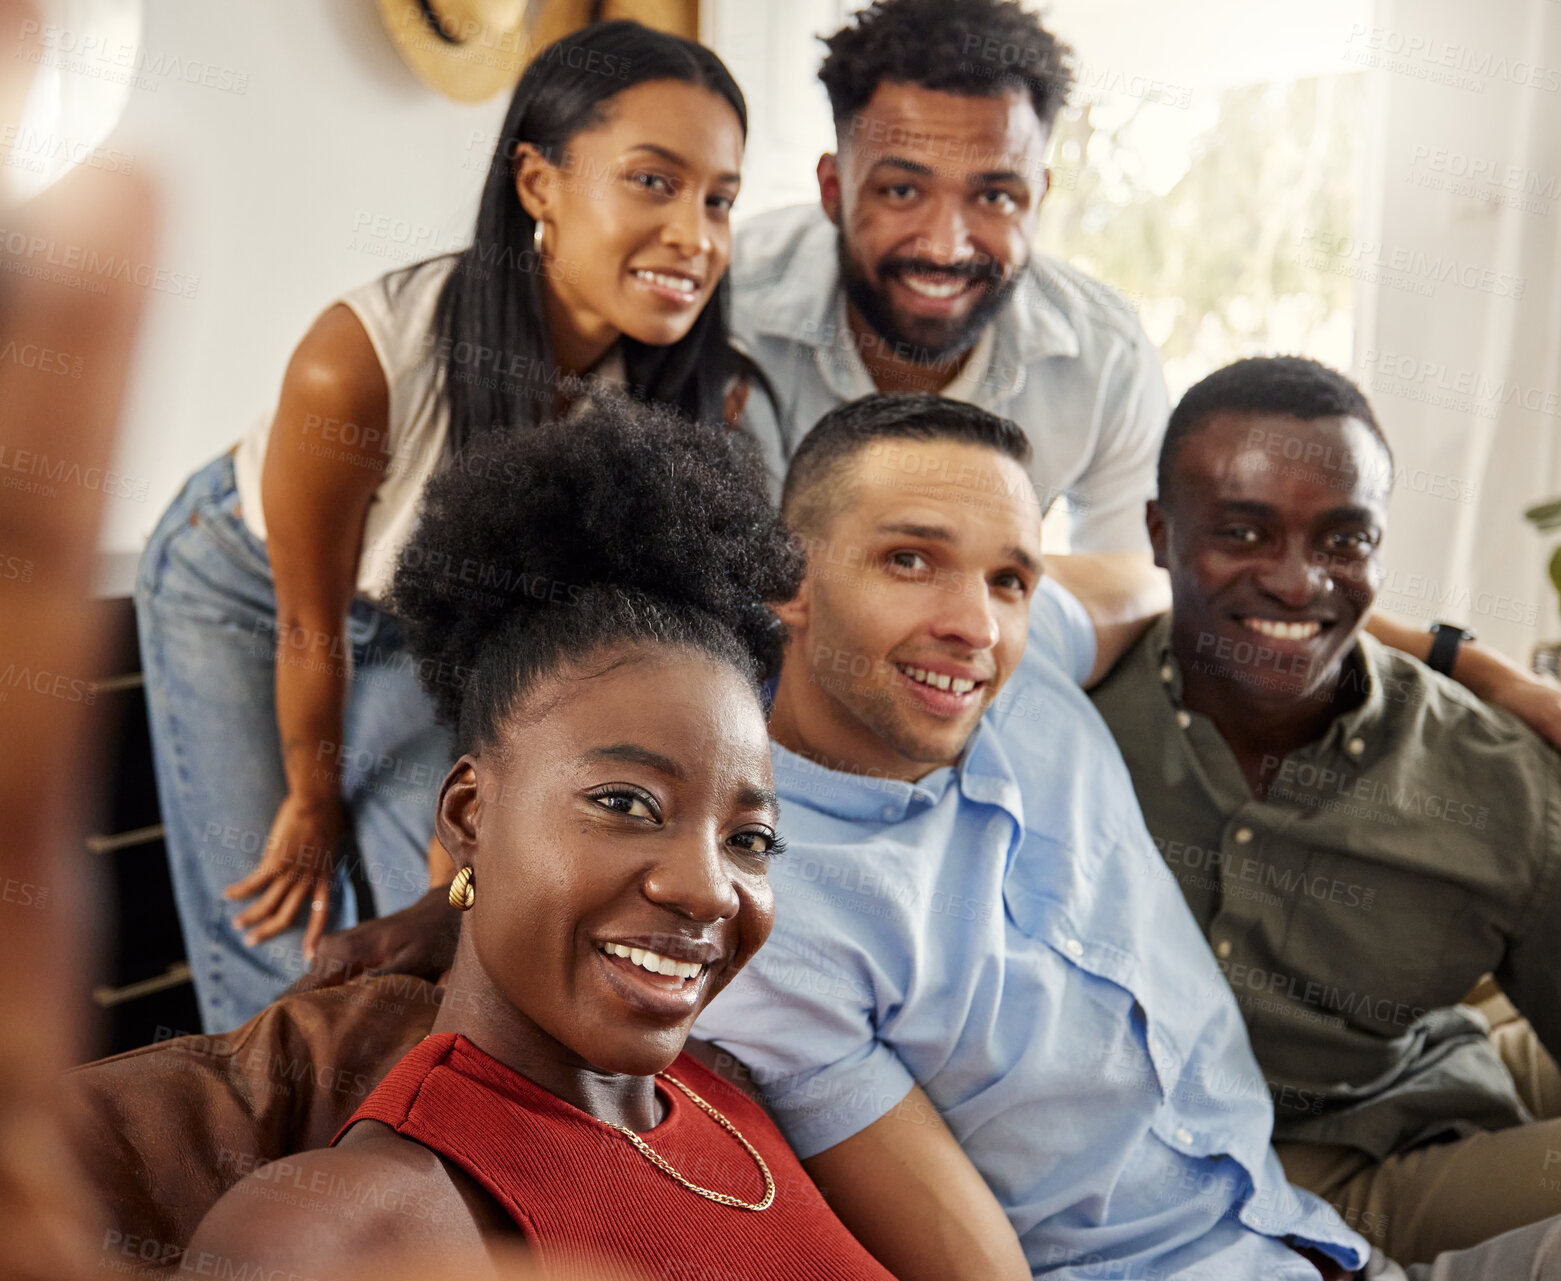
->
[105, 0, 507, 551]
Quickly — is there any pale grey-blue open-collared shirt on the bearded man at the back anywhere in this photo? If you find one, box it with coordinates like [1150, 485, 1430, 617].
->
[732, 204, 1171, 552]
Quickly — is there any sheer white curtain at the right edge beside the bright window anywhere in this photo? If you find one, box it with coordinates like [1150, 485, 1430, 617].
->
[1354, 0, 1561, 663]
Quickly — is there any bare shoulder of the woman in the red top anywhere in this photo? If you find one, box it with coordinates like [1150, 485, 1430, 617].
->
[183, 1122, 493, 1276]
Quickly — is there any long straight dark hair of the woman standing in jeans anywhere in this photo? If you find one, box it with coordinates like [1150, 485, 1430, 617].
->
[434, 20, 748, 452]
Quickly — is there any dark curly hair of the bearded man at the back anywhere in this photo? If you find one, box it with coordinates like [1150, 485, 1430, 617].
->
[818, 0, 1072, 131]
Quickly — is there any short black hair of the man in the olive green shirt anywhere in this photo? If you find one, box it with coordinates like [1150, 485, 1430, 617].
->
[1157, 356, 1392, 502]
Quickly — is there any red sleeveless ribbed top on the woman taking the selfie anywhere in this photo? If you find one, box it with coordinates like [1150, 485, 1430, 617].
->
[332, 1033, 893, 1281]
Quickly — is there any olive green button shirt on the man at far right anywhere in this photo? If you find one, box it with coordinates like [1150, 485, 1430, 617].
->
[1093, 615, 1561, 1159]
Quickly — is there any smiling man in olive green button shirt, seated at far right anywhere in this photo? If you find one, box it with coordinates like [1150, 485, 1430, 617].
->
[1094, 357, 1561, 1262]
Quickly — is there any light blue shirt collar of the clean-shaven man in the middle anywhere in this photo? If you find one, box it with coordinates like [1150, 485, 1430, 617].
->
[770, 721, 1024, 827]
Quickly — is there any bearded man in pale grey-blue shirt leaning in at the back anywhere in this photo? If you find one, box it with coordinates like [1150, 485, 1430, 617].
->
[732, 0, 1169, 546]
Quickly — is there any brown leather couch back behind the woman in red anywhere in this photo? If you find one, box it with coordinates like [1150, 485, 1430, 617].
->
[64, 975, 445, 1272]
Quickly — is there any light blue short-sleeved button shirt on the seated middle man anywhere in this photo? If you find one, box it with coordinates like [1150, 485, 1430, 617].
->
[695, 590, 1366, 1281]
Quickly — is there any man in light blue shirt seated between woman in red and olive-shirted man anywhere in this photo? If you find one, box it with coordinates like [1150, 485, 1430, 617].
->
[696, 396, 1549, 1281]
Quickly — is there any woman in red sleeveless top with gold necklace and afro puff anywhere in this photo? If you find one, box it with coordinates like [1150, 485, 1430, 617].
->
[184, 401, 888, 1281]
